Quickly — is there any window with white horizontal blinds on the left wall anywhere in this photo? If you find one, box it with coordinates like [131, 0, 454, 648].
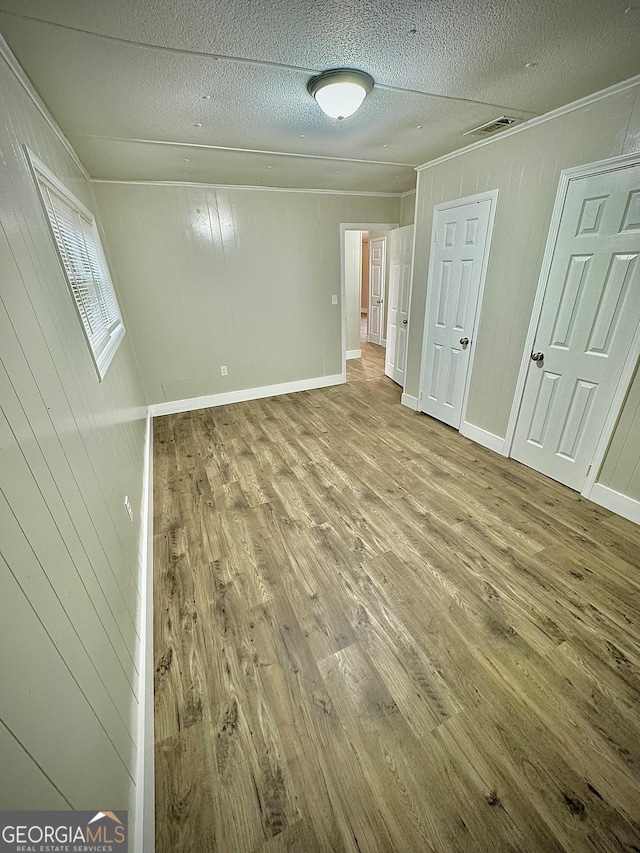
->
[29, 152, 124, 380]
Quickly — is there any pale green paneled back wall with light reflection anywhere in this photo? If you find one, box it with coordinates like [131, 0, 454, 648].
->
[94, 183, 400, 403]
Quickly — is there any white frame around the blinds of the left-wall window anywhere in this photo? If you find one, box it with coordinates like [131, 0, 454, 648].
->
[25, 146, 125, 382]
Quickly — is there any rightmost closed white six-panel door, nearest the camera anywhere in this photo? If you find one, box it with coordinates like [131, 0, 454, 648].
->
[511, 165, 640, 489]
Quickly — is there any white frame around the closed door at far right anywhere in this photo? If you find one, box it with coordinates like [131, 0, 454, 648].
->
[504, 151, 640, 499]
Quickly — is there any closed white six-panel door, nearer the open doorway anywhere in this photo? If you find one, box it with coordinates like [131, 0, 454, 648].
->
[419, 197, 495, 429]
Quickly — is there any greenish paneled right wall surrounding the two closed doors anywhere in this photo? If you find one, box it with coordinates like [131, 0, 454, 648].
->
[405, 80, 640, 492]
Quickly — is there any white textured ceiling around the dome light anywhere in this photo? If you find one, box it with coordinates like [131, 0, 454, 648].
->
[0, 0, 640, 192]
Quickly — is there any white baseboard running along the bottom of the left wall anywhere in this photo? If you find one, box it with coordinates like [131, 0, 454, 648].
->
[133, 414, 155, 853]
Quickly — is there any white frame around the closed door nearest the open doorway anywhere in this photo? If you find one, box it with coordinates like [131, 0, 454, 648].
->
[412, 189, 498, 438]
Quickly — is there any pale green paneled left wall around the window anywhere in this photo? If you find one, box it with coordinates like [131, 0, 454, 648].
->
[0, 48, 146, 824]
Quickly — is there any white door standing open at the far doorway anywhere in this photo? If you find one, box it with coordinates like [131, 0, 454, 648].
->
[384, 225, 413, 388]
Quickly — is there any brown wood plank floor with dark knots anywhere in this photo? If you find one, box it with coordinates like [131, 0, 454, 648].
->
[154, 344, 640, 853]
